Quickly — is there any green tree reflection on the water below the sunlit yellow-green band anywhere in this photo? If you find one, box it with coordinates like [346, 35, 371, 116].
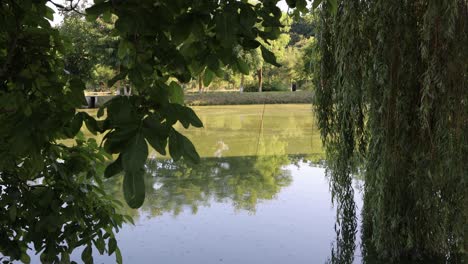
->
[106, 155, 318, 219]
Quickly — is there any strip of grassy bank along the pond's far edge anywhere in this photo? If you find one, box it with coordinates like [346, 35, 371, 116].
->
[185, 91, 312, 106]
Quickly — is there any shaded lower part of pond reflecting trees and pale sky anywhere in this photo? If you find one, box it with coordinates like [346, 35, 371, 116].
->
[93, 155, 348, 263]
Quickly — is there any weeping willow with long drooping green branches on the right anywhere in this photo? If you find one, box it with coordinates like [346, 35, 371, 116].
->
[315, 0, 468, 262]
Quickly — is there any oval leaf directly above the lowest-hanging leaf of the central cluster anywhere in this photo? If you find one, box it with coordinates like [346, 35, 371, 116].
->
[122, 133, 148, 172]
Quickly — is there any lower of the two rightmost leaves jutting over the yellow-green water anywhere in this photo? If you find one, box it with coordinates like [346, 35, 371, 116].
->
[169, 129, 200, 163]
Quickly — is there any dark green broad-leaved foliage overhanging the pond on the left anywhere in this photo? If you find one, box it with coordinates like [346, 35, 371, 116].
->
[0, 0, 304, 263]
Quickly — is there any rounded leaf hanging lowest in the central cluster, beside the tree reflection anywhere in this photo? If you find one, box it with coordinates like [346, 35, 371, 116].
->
[123, 168, 145, 209]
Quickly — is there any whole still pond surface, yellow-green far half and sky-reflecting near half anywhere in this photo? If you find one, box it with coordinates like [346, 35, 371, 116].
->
[75, 105, 361, 264]
